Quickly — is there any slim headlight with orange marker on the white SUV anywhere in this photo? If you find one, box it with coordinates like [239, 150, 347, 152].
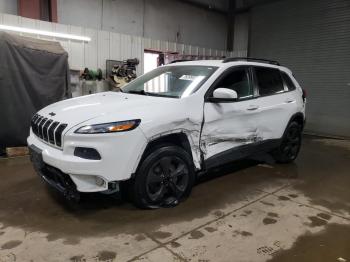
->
[74, 119, 141, 134]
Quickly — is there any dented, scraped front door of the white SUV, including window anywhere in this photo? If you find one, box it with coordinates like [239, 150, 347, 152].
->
[201, 67, 259, 166]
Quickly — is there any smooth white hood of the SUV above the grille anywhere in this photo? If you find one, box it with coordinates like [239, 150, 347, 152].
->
[38, 92, 180, 128]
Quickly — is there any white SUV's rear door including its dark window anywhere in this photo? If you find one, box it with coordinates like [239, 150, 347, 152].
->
[253, 66, 297, 140]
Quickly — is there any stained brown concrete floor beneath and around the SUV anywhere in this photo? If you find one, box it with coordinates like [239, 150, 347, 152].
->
[0, 137, 350, 262]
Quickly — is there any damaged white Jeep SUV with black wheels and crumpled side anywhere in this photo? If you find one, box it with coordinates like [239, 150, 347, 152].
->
[28, 58, 305, 208]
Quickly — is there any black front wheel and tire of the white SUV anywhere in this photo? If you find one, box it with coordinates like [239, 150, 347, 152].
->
[129, 145, 195, 209]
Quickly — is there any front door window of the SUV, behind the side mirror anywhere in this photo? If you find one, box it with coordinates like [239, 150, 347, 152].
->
[216, 68, 253, 99]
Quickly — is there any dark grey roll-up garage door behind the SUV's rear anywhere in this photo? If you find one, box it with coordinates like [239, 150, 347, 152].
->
[249, 0, 350, 137]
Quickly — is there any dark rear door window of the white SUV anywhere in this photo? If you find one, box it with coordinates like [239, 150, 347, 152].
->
[255, 67, 284, 96]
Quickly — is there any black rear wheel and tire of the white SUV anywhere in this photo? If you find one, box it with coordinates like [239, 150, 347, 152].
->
[272, 121, 302, 164]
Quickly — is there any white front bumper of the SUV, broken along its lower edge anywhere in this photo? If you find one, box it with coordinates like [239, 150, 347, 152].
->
[27, 128, 146, 192]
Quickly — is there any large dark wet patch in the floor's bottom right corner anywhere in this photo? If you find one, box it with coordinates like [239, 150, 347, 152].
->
[269, 224, 350, 262]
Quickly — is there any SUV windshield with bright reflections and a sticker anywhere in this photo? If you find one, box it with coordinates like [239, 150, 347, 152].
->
[122, 66, 217, 98]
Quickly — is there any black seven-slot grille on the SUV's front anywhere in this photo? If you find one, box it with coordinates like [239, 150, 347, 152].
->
[31, 114, 67, 147]
